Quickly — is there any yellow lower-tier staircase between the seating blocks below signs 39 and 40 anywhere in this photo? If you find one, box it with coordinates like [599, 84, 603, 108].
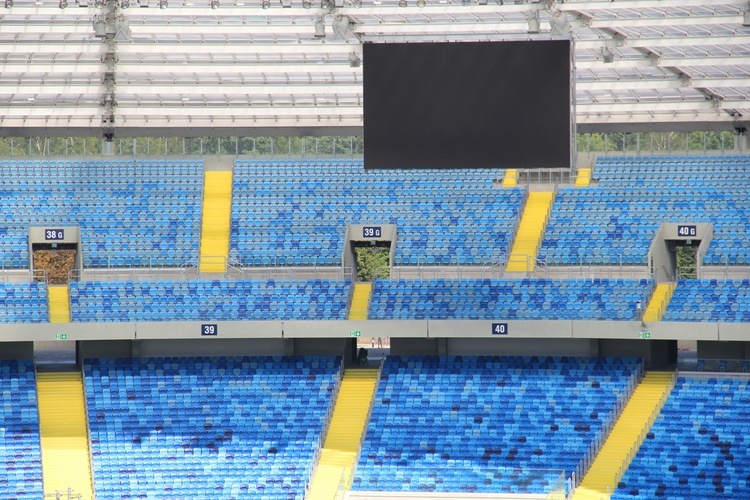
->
[306, 368, 378, 500]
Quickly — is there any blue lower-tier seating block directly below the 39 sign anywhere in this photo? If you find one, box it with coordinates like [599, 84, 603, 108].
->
[84, 357, 341, 500]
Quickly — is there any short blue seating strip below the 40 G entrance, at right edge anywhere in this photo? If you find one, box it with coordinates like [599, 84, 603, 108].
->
[662, 279, 750, 323]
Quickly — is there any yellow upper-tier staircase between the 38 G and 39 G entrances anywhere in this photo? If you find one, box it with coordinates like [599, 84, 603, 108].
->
[200, 170, 232, 273]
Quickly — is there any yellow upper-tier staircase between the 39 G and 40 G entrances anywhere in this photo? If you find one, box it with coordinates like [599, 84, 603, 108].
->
[505, 191, 555, 272]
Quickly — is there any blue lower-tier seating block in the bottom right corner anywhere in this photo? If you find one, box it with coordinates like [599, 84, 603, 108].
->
[612, 377, 750, 500]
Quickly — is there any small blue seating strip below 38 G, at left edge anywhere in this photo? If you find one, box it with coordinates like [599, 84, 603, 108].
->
[0, 282, 49, 323]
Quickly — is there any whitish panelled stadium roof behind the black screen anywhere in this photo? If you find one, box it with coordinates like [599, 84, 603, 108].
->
[0, 0, 750, 136]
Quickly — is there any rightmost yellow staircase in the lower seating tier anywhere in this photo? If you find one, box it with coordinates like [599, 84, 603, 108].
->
[573, 372, 674, 500]
